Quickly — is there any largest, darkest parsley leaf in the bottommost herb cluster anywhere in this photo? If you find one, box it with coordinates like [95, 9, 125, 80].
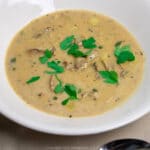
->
[64, 84, 77, 99]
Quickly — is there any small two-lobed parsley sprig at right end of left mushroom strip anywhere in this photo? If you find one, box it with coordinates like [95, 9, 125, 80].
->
[39, 49, 53, 64]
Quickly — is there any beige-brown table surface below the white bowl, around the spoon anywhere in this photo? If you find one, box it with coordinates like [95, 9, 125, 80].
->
[0, 114, 150, 150]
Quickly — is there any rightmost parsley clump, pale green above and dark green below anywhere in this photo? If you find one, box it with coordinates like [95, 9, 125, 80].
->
[114, 41, 135, 64]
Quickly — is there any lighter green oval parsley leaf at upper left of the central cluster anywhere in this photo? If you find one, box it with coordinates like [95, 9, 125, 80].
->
[60, 35, 75, 50]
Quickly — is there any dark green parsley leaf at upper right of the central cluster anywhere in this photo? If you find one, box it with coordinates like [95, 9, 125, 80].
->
[82, 37, 97, 49]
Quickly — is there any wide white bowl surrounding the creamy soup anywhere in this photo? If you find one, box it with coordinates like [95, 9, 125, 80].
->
[0, 0, 150, 135]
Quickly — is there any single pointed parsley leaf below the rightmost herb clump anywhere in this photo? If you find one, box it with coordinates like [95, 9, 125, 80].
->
[99, 71, 118, 84]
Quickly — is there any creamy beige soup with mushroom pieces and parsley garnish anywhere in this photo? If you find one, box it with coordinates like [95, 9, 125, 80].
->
[6, 10, 144, 118]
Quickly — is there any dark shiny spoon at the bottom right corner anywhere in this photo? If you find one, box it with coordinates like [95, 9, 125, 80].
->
[99, 139, 150, 150]
